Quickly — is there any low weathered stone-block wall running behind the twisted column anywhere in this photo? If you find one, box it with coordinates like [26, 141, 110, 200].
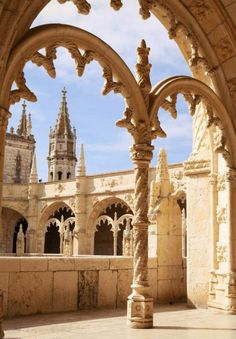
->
[0, 256, 186, 317]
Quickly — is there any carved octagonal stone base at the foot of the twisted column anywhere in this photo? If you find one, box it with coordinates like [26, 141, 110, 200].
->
[127, 286, 153, 328]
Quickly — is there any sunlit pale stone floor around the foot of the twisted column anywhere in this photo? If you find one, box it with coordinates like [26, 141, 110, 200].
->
[3, 304, 236, 339]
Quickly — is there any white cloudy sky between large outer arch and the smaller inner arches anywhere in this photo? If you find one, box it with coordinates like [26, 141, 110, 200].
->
[33, 0, 190, 81]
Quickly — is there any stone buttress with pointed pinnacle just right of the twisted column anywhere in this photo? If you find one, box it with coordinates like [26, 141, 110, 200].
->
[149, 149, 186, 302]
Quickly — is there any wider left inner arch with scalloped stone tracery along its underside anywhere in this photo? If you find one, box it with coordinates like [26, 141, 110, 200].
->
[0, 24, 148, 134]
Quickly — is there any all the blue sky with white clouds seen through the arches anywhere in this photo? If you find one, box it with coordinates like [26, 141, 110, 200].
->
[9, 0, 192, 180]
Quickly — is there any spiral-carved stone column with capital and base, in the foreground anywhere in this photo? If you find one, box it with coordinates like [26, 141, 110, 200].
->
[127, 144, 153, 328]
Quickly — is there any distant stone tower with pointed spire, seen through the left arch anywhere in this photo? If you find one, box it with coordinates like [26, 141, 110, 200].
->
[47, 88, 76, 181]
